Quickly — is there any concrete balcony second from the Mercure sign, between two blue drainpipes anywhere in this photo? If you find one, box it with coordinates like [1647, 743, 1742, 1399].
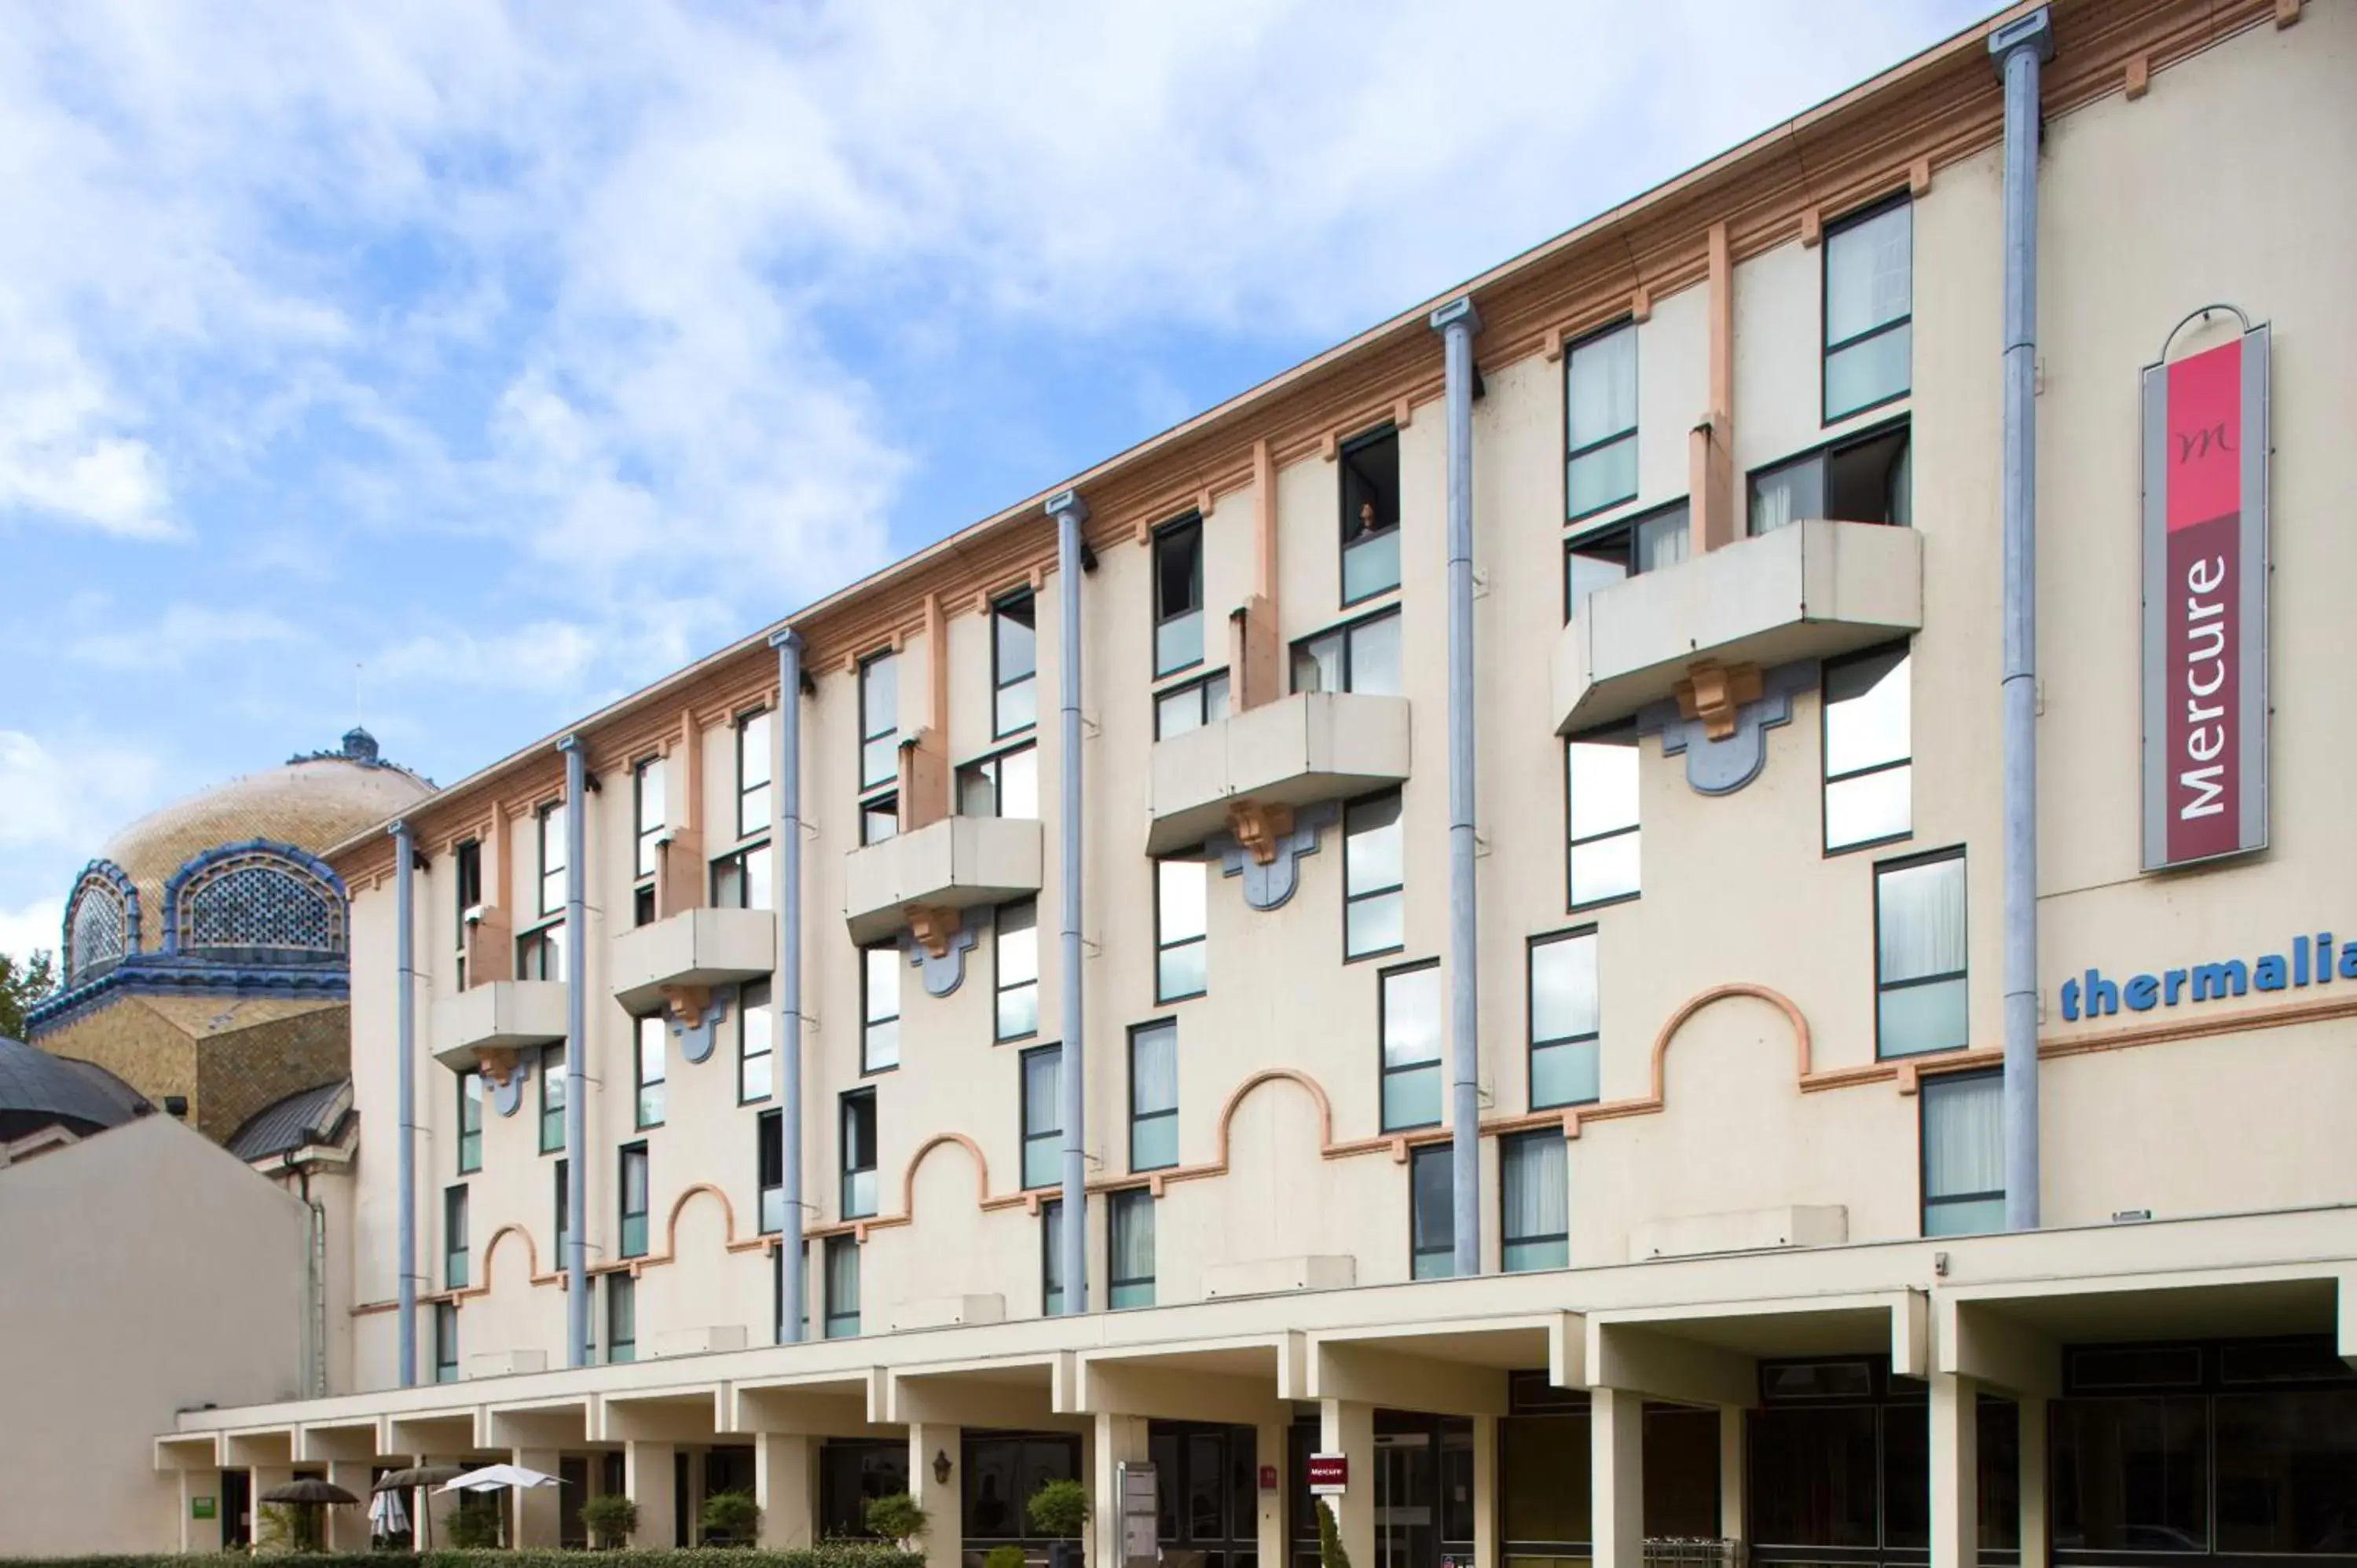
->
[1146, 691, 1407, 854]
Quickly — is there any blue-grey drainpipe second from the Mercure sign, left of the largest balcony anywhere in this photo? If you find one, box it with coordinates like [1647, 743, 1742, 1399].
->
[1433, 295, 1480, 1278]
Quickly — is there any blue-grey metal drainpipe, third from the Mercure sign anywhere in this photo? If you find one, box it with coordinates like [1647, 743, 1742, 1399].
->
[1047, 490, 1089, 1313]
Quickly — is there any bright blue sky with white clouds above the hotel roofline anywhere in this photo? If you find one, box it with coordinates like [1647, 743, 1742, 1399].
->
[0, 0, 1987, 953]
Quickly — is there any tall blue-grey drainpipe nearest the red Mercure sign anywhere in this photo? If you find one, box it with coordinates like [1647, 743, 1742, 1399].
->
[1989, 7, 2055, 1231]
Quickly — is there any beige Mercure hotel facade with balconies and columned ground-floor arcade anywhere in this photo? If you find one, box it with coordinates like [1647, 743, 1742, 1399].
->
[134, 0, 2357, 1568]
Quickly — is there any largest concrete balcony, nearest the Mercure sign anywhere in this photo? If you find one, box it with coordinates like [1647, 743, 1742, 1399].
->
[1553, 521, 1923, 735]
